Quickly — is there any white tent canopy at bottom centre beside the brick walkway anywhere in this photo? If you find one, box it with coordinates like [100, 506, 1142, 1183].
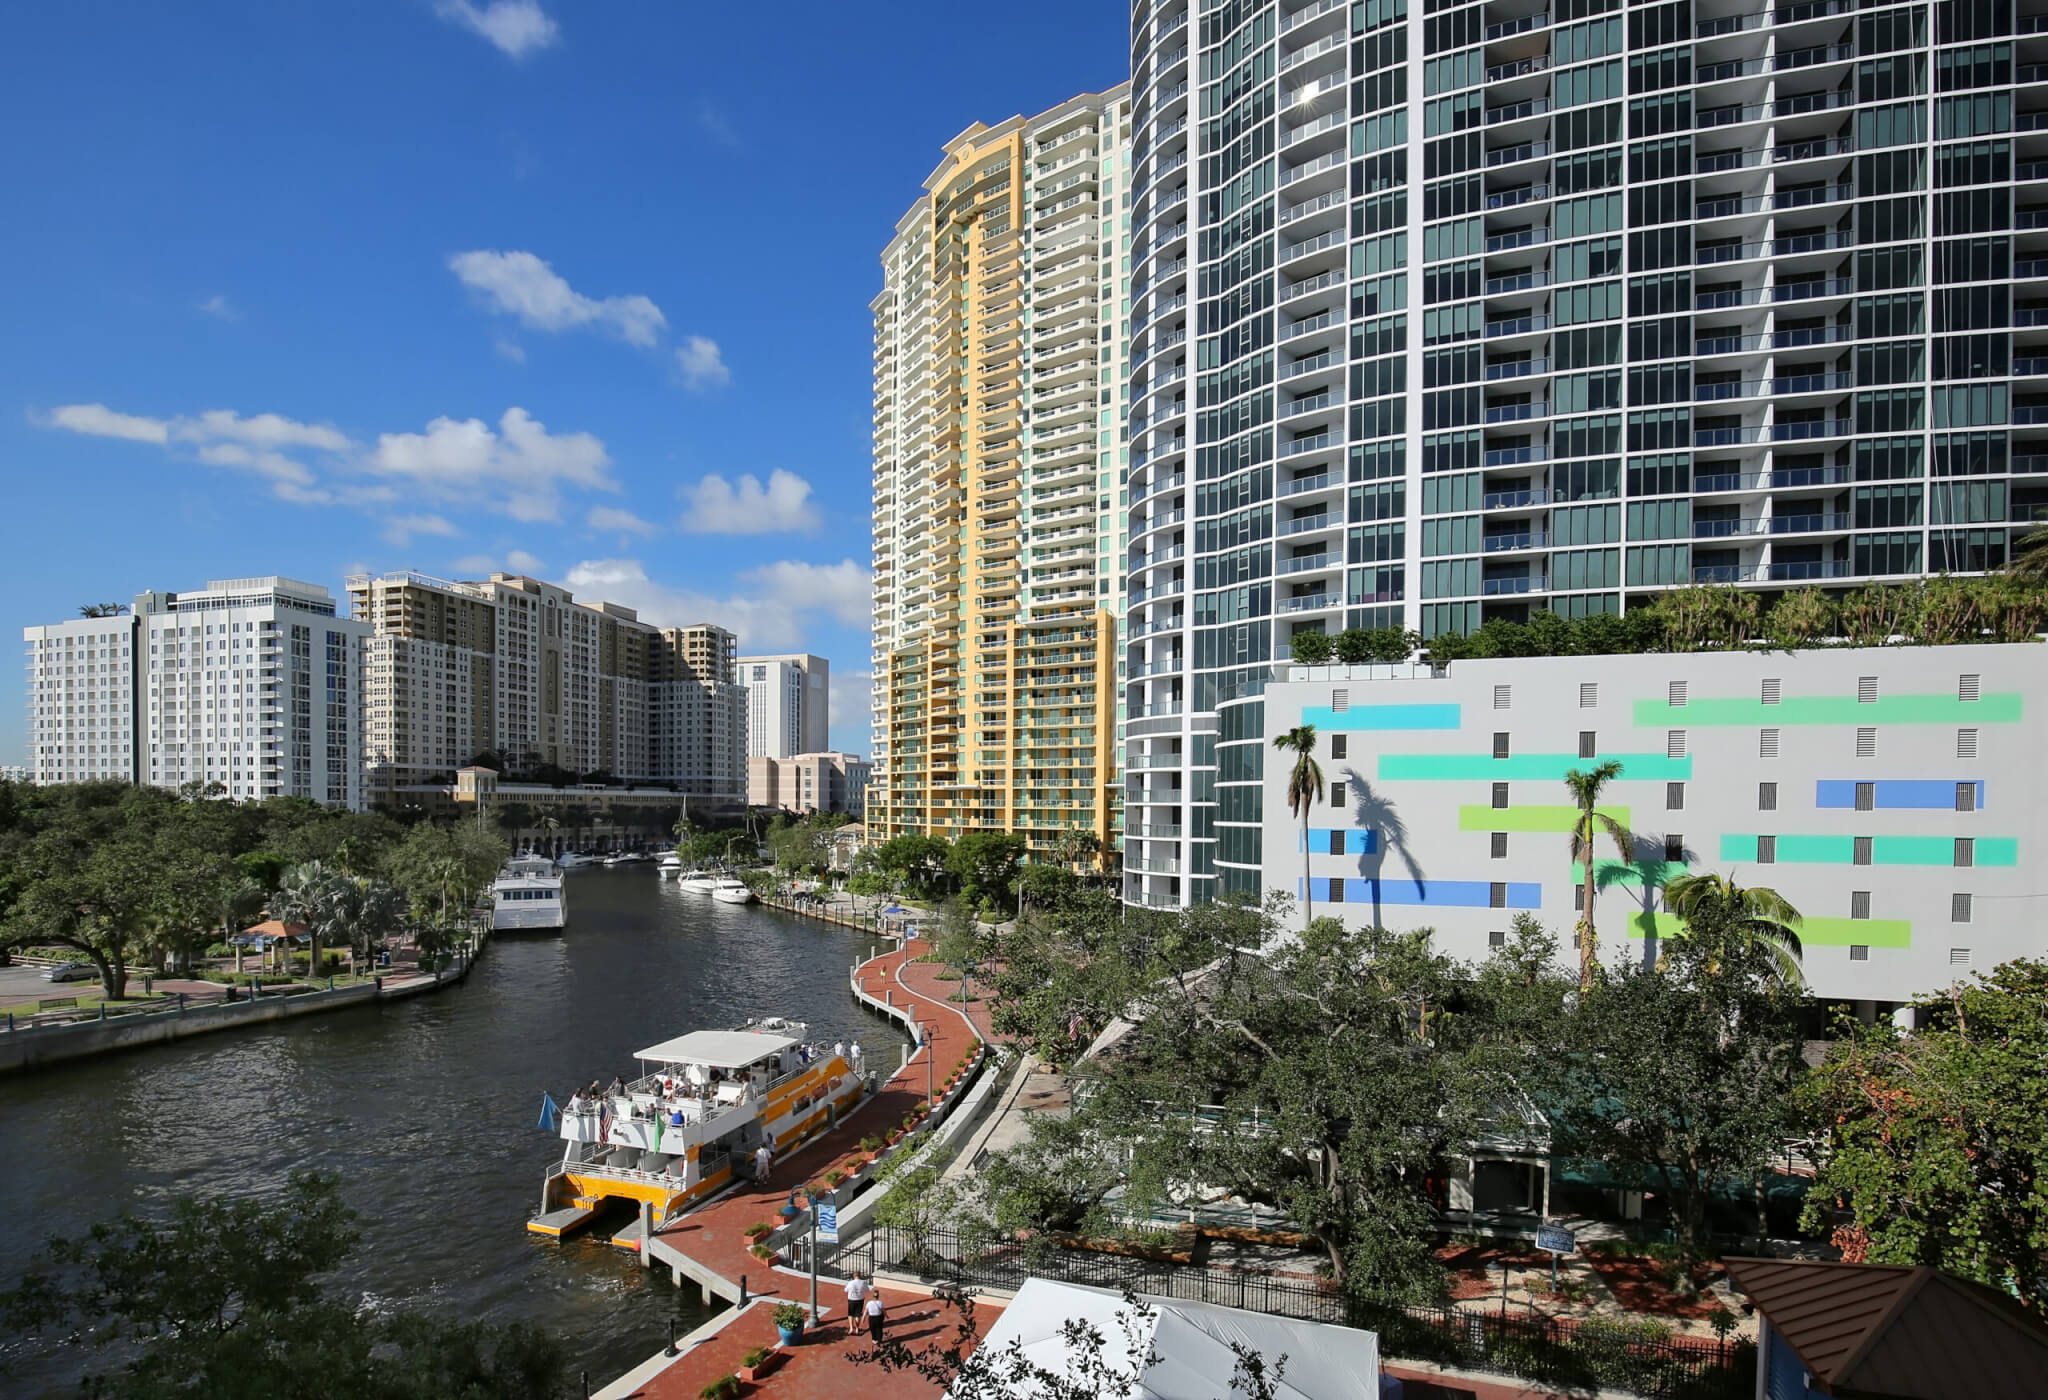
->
[975, 1279, 1380, 1400]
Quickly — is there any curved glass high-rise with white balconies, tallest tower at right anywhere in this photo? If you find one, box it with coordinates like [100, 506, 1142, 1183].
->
[1124, 0, 2048, 905]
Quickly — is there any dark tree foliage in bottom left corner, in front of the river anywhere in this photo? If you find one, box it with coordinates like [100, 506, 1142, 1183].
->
[0, 1175, 567, 1400]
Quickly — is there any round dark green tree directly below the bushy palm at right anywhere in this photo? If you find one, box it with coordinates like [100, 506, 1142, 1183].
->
[1532, 937, 1800, 1259]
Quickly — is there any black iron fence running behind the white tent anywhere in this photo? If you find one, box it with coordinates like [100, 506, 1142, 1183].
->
[831, 1226, 1757, 1400]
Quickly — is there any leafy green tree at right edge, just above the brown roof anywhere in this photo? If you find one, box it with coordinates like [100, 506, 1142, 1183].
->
[1804, 960, 2048, 1312]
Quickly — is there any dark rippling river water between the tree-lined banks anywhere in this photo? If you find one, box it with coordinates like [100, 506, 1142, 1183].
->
[0, 866, 901, 1396]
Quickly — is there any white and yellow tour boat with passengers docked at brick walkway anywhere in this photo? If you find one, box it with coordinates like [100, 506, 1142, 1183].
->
[526, 1017, 862, 1244]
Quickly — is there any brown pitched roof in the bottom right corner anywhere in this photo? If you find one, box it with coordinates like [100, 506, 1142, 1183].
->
[1724, 1259, 2048, 1400]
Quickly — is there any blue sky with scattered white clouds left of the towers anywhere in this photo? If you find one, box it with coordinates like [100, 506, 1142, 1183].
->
[0, 0, 1128, 761]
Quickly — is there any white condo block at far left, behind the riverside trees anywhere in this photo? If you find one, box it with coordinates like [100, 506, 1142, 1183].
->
[23, 575, 369, 811]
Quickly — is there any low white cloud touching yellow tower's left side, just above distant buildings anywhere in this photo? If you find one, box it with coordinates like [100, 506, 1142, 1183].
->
[563, 559, 870, 651]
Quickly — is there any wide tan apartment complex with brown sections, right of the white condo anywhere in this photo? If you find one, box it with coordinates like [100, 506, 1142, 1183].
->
[348, 571, 745, 798]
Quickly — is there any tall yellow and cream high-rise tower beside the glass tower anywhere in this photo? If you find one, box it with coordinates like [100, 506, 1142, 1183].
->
[866, 88, 1130, 849]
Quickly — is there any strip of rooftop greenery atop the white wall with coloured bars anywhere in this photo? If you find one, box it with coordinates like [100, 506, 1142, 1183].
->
[1292, 575, 2048, 665]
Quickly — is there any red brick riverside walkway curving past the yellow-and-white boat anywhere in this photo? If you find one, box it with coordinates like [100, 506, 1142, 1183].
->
[643, 944, 985, 1309]
